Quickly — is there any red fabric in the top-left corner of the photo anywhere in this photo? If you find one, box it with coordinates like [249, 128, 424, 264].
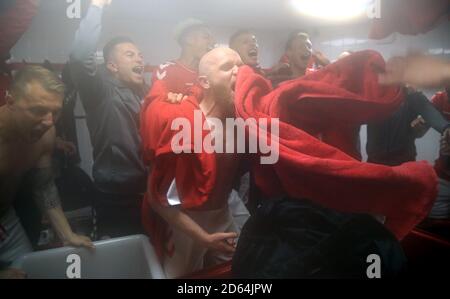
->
[0, 0, 38, 58]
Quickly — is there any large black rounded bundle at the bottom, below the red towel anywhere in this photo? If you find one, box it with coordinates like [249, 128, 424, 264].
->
[232, 199, 406, 279]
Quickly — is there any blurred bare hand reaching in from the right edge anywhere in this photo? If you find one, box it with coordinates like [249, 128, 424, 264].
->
[379, 54, 450, 88]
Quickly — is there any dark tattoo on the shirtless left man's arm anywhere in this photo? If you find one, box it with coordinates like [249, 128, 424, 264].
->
[30, 167, 61, 212]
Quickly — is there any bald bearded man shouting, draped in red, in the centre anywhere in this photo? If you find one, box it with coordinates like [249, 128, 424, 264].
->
[141, 48, 242, 278]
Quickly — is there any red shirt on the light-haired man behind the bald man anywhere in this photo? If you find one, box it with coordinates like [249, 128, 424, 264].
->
[152, 61, 198, 95]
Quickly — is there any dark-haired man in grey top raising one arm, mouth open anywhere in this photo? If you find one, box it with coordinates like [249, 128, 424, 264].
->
[70, 0, 147, 237]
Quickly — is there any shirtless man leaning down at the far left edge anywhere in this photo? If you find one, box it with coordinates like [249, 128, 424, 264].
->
[0, 67, 93, 277]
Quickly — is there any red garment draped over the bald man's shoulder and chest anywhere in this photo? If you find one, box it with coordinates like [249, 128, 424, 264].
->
[141, 81, 216, 258]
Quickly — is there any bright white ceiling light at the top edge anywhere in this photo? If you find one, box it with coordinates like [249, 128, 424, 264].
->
[292, 0, 376, 21]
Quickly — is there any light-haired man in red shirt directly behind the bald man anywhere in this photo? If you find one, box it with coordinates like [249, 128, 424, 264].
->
[153, 19, 214, 95]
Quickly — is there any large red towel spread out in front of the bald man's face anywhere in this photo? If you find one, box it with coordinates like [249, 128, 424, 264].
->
[235, 51, 437, 239]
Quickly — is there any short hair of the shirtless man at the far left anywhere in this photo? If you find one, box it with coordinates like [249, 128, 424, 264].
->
[10, 66, 65, 98]
